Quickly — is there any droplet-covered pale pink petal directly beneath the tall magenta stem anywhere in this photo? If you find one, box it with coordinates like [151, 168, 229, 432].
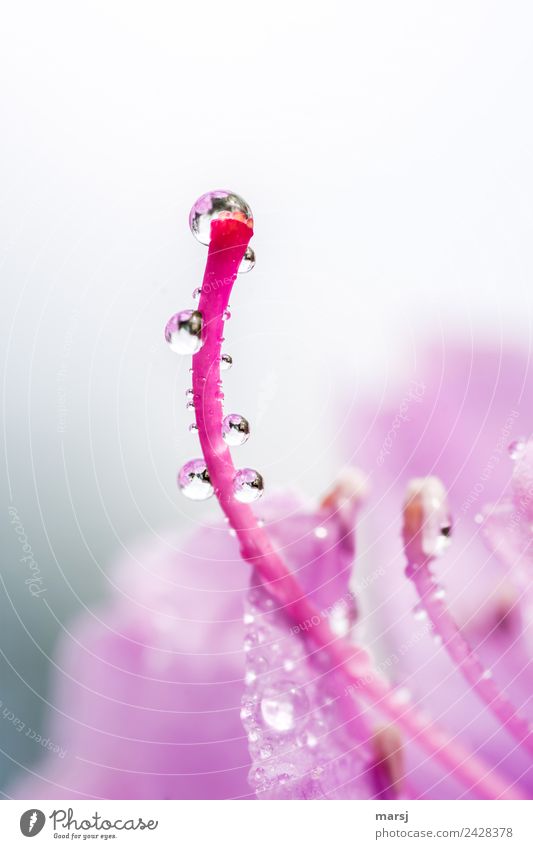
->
[241, 581, 368, 799]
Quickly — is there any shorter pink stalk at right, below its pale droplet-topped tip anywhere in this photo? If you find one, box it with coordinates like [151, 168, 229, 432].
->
[405, 561, 533, 754]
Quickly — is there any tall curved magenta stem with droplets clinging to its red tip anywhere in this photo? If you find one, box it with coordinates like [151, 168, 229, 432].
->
[193, 219, 521, 799]
